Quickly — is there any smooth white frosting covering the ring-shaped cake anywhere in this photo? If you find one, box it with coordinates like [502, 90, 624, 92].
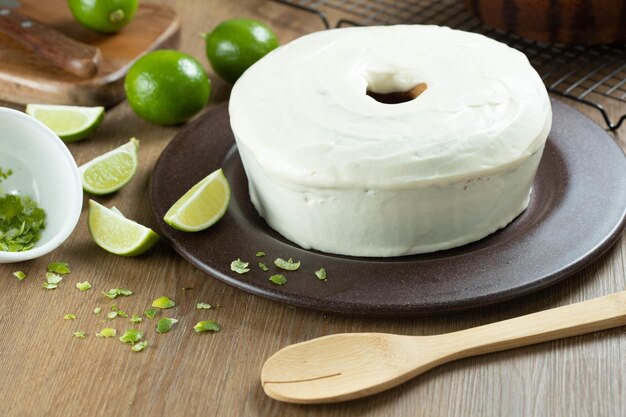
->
[229, 26, 551, 256]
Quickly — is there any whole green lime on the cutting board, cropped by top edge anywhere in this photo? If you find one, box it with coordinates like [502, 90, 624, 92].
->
[67, 0, 139, 33]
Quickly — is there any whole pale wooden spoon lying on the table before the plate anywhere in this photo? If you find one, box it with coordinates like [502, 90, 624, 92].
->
[261, 291, 626, 404]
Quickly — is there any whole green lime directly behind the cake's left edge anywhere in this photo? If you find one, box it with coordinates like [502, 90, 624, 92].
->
[205, 19, 278, 83]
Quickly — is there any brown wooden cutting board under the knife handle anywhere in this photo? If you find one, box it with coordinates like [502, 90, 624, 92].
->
[0, 0, 180, 106]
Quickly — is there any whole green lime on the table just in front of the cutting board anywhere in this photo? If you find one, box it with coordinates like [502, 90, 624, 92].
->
[124, 50, 211, 125]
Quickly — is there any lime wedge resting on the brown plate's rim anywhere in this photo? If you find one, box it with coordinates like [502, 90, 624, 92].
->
[163, 168, 230, 232]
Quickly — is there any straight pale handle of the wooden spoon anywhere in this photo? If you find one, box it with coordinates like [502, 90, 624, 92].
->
[445, 291, 626, 360]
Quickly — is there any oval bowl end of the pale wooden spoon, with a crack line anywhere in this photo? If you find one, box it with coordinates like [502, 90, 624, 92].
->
[261, 333, 439, 404]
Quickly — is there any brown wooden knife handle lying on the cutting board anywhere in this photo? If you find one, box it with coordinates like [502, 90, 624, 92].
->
[0, 8, 102, 78]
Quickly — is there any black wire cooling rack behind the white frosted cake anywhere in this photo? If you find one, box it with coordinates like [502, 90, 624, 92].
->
[274, 0, 626, 130]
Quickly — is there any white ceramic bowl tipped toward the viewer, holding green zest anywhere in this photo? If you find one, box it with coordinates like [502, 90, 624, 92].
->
[0, 107, 83, 263]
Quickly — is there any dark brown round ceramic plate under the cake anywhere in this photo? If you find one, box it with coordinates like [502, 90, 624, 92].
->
[151, 101, 626, 316]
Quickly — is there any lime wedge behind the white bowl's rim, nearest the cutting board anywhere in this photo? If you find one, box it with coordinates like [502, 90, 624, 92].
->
[26, 104, 104, 142]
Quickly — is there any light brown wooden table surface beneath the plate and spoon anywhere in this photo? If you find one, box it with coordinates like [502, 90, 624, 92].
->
[0, 0, 626, 417]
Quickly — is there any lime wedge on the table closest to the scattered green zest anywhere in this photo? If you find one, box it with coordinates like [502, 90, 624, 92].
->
[88, 200, 159, 256]
